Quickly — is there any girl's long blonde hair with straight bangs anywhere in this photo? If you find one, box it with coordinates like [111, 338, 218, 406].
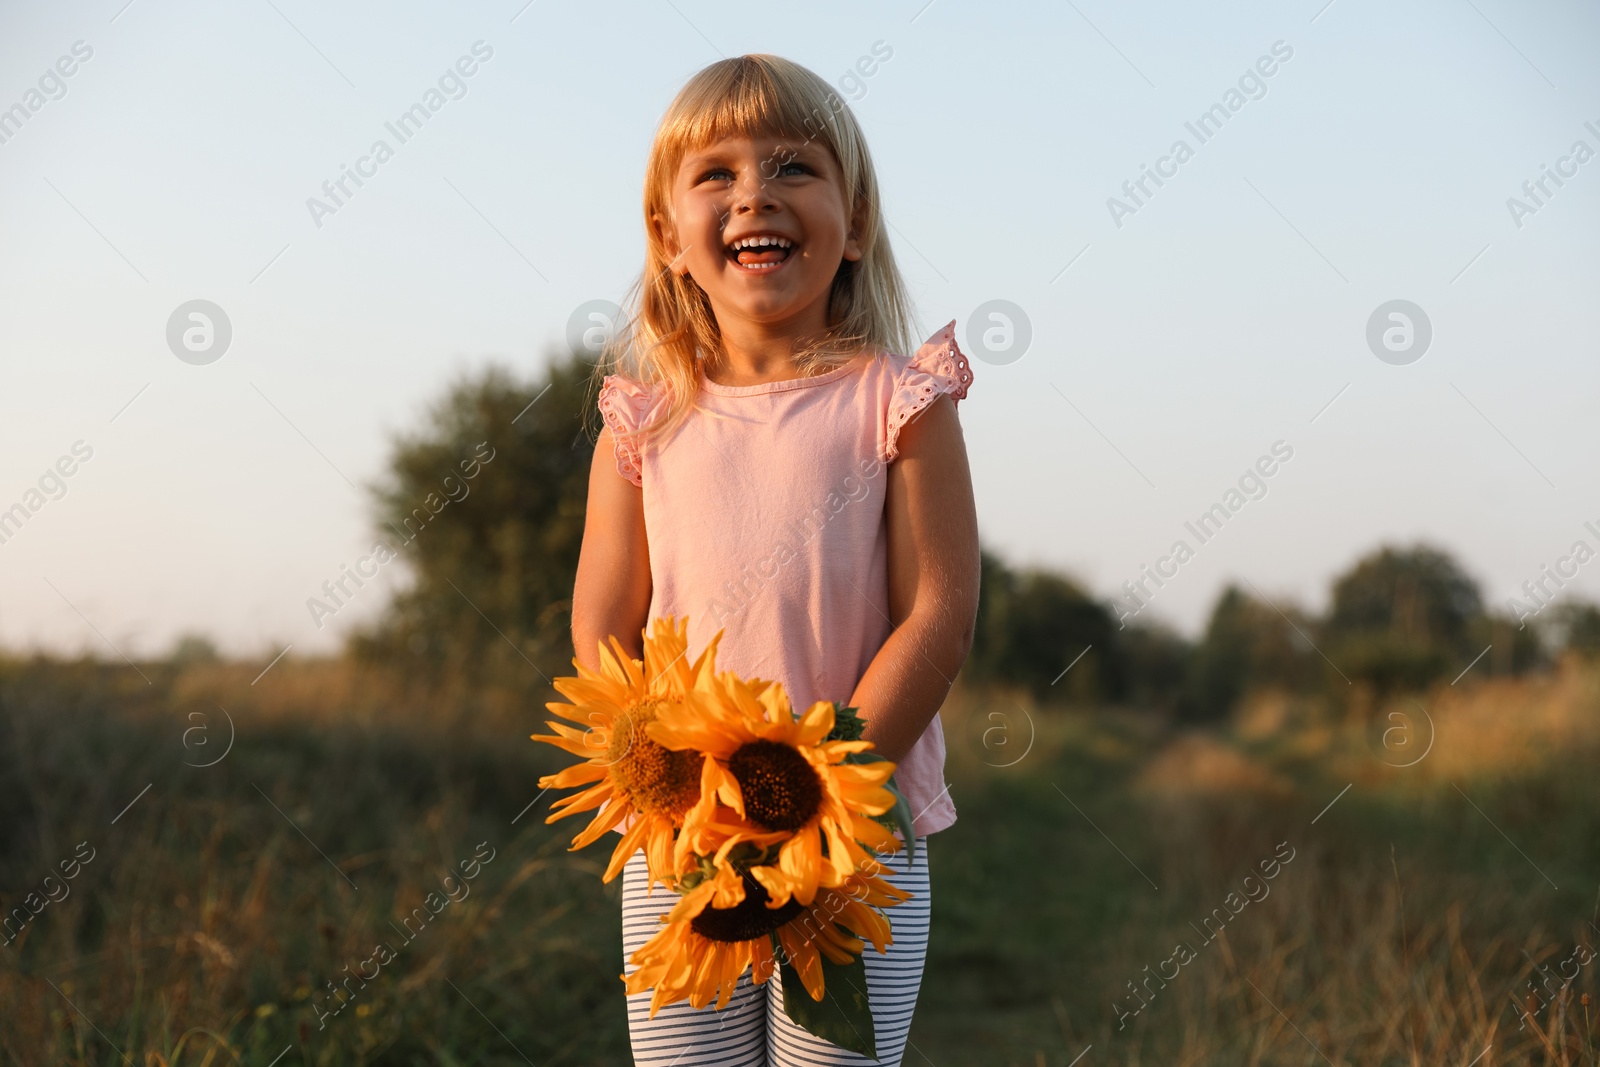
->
[595, 54, 910, 440]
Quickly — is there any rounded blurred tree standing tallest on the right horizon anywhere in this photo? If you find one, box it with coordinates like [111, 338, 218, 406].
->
[1322, 544, 1483, 697]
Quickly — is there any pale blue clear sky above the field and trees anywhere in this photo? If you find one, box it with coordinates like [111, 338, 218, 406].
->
[0, 0, 1600, 659]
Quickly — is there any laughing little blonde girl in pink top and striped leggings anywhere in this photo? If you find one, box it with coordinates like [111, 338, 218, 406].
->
[573, 56, 978, 1067]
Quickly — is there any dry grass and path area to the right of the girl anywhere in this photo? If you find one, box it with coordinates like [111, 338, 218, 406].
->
[934, 662, 1600, 1067]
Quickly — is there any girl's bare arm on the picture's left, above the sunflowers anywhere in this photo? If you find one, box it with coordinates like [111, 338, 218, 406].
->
[573, 427, 652, 670]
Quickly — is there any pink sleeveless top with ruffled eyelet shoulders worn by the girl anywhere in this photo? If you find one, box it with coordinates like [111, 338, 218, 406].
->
[600, 322, 973, 835]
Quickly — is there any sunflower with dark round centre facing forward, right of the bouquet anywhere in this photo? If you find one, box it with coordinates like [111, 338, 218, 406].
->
[645, 672, 901, 907]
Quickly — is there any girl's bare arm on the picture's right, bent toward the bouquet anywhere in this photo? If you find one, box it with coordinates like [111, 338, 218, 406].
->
[850, 395, 979, 761]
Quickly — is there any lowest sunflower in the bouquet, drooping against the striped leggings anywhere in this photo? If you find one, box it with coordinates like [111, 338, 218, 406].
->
[622, 864, 910, 1019]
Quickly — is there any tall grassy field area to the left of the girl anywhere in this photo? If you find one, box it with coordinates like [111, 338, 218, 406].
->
[0, 661, 627, 1065]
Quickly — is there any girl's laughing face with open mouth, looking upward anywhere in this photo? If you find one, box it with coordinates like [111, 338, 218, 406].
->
[656, 138, 861, 336]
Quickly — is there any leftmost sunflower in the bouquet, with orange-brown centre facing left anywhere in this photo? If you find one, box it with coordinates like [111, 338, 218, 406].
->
[531, 619, 722, 885]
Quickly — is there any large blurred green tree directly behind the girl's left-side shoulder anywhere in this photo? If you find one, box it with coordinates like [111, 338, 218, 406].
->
[352, 355, 594, 678]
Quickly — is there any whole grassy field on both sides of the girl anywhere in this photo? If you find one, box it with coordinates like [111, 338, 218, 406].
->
[0, 661, 1600, 1067]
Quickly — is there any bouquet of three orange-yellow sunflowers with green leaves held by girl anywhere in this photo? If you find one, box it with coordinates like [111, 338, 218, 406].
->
[533, 619, 915, 1056]
